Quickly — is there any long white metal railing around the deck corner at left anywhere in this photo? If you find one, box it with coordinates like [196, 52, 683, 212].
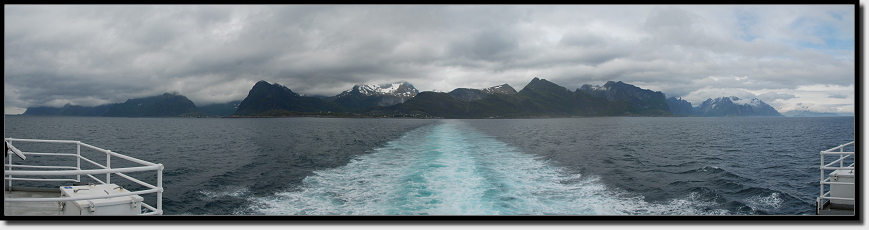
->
[4, 138, 163, 215]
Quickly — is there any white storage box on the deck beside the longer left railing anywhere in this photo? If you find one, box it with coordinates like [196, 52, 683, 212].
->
[60, 184, 143, 216]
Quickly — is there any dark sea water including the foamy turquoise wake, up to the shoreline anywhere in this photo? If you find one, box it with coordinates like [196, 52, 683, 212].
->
[4, 116, 855, 215]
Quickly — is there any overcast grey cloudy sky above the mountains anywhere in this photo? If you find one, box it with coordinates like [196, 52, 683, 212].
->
[3, 5, 856, 114]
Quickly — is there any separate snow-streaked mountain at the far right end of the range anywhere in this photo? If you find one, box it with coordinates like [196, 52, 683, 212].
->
[694, 96, 782, 117]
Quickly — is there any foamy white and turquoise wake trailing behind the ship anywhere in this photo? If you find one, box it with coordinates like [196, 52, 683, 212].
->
[249, 120, 728, 215]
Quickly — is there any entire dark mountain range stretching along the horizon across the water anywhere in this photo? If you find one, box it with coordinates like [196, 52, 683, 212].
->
[24, 78, 782, 118]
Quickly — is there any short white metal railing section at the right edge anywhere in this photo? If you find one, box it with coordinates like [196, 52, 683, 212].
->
[817, 141, 856, 214]
